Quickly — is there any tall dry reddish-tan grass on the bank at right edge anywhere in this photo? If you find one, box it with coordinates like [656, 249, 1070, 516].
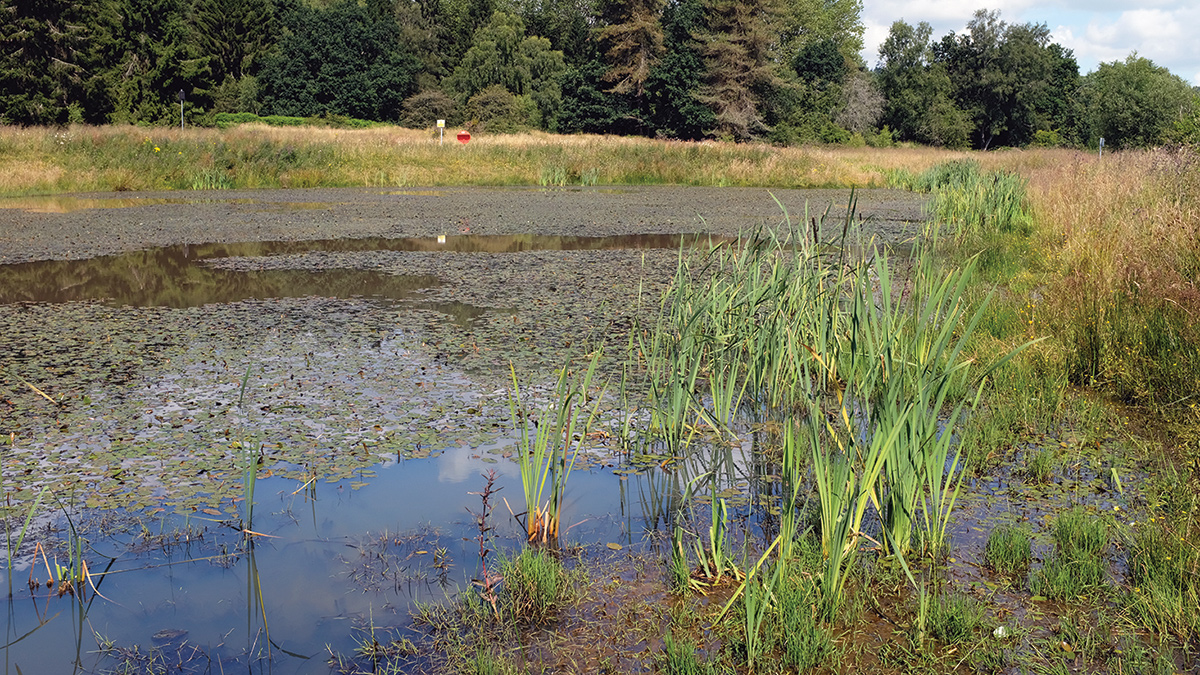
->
[1013, 149, 1200, 412]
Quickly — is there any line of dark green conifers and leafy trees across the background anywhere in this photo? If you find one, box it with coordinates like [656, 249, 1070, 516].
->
[0, 0, 1200, 149]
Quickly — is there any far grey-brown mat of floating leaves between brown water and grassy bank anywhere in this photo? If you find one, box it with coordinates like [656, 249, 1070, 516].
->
[0, 186, 924, 263]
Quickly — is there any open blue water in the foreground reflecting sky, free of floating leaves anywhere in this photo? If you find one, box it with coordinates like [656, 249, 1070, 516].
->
[6, 446, 696, 675]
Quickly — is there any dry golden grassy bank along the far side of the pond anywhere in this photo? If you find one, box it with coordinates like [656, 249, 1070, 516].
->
[0, 125, 916, 196]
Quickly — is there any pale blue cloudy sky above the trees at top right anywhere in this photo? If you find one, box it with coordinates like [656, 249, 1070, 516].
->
[862, 0, 1200, 86]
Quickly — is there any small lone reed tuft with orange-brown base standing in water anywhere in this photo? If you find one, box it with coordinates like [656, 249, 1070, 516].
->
[509, 351, 604, 544]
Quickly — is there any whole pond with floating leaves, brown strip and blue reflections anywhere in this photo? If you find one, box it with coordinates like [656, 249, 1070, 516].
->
[0, 190, 1134, 675]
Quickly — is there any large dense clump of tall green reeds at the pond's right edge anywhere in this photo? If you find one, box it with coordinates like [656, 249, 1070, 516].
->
[636, 200, 1027, 624]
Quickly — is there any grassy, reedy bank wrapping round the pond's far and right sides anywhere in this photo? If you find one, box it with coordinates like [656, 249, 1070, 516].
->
[0, 126, 1200, 674]
